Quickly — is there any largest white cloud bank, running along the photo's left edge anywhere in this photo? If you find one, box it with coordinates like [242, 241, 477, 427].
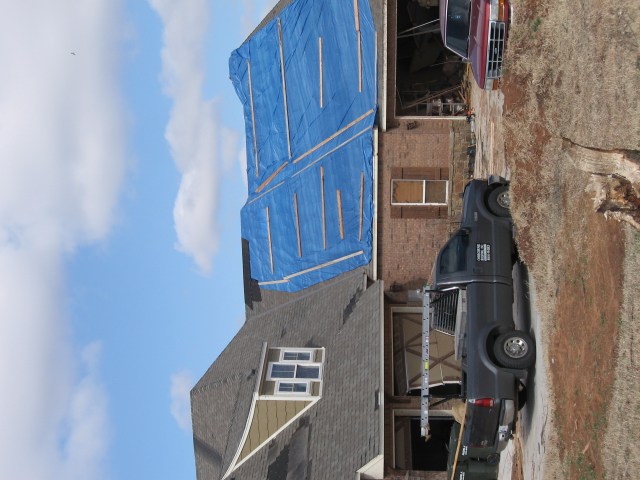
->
[0, 0, 126, 480]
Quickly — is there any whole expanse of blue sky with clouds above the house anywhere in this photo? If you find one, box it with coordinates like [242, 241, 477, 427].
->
[0, 0, 275, 480]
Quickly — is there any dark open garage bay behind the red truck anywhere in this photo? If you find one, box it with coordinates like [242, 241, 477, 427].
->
[395, 0, 466, 117]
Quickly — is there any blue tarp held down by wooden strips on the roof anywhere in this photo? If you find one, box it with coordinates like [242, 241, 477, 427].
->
[229, 0, 377, 291]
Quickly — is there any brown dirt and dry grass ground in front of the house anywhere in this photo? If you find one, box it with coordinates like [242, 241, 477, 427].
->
[468, 0, 640, 479]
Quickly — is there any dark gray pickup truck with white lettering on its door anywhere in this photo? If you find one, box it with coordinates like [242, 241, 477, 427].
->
[429, 177, 535, 457]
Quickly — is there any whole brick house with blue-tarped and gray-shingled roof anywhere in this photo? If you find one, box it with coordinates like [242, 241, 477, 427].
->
[191, 0, 471, 480]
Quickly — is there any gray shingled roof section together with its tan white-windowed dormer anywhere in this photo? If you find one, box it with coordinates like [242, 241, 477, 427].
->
[191, 268, 383, 480]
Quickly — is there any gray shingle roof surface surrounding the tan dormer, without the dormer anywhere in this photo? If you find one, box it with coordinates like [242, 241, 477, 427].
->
[191, 269, 383, 480]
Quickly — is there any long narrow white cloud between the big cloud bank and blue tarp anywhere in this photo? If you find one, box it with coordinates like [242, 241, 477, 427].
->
[149, 0, 244, 273]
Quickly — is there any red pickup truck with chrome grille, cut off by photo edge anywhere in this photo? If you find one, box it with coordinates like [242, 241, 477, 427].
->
[440, 0, 511, 90]
